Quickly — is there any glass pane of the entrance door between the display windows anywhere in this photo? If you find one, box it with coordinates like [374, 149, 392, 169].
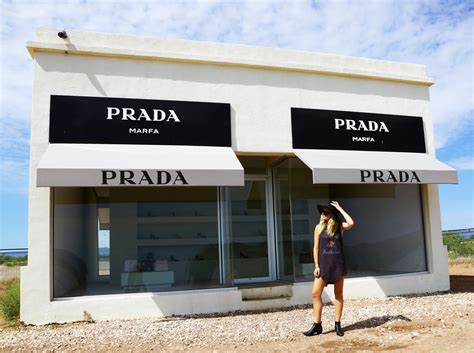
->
[229, 181, 269, 279]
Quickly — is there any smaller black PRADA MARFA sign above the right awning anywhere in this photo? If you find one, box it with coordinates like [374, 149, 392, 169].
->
[291, 108, 426, 153]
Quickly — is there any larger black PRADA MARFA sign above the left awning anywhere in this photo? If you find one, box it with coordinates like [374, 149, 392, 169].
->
[49, 96, 231, 147]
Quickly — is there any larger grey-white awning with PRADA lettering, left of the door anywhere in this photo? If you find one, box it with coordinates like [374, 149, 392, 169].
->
[36, 143, 244, 186]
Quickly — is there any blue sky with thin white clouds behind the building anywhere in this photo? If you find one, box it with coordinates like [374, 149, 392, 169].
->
[0, 0, 474, 248]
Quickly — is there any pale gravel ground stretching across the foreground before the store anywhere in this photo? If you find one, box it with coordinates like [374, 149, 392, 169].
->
[0, 292, 474, 352]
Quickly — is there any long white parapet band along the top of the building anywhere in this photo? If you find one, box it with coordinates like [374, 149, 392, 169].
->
[26, 27, 434, 86]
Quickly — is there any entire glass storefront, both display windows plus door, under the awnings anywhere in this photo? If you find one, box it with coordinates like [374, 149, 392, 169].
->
[54, 158, 427, 297]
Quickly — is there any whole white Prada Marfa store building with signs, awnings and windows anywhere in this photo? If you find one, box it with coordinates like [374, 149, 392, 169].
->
[21, 28, 457, 324]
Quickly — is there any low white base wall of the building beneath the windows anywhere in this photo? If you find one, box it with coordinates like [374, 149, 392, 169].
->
[21, 256, 449, 324]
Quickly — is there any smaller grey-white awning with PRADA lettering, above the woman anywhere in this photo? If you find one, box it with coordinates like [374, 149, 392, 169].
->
[294, 149, 458, 184]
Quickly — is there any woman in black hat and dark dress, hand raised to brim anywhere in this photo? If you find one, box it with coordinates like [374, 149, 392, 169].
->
[303, 201, 354, 336]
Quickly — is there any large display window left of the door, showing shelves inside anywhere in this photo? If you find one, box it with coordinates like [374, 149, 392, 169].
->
[54, 187, 220, 297]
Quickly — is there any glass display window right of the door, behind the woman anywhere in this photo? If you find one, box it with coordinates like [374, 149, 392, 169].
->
[273, 158, 427, 281]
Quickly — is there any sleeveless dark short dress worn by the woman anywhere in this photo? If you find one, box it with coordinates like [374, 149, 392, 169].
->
[318, 228, 347, 286]
